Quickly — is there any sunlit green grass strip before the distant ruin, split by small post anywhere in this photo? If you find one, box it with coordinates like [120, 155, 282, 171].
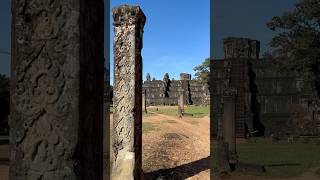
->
[148, 106, 210, 118]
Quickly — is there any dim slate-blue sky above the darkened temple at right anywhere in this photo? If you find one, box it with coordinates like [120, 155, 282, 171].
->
[211, 0, 298, 58]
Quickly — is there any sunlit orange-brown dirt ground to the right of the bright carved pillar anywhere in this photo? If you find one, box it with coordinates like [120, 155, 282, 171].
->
[142, 113, 210, 180]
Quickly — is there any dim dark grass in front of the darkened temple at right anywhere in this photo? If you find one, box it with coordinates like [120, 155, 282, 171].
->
[214, 139, 320, 177]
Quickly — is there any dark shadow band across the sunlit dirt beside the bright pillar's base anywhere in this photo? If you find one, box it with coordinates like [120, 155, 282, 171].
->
[145, 156, 210, 180]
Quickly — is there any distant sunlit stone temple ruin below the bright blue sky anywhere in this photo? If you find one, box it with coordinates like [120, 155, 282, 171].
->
[143, 73, 210, 106]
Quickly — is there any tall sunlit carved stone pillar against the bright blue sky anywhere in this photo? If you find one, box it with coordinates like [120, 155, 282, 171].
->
[112, 5, 146, 180]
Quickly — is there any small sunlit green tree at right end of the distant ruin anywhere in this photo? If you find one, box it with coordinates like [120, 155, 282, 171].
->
[193, 58, 210, 84]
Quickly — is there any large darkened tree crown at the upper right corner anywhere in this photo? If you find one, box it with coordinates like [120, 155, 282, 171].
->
[267, 0, 320, 95]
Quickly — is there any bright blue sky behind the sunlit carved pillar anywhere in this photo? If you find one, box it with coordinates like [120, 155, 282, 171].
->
[110, 0, 210, 82]
